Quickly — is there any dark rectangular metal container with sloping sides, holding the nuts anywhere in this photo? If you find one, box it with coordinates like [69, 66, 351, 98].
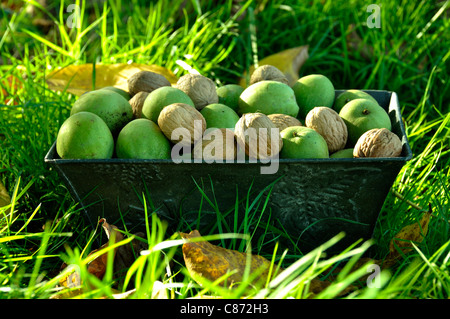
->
[45, 90, 412, 255]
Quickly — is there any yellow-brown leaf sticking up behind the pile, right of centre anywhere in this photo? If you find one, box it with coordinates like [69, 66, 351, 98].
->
[239, 45, 309, 87]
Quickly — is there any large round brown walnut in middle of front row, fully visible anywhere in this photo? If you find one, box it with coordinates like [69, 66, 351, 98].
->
[234, 113, 283, 159]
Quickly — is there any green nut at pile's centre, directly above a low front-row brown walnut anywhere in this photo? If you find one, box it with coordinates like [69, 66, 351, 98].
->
[200, 103, 239, 128]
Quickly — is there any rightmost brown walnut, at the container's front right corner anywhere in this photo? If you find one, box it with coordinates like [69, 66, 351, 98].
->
[353, 128, 402, 157]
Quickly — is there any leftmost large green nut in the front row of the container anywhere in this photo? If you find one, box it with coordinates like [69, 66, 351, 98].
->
[56, 112, 114, 159]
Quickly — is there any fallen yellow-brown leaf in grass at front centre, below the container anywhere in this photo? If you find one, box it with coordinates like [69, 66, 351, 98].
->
[180, 230, 278, 285]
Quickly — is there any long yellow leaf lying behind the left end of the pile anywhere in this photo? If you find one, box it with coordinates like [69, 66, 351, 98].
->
[46, 63, 178, 95]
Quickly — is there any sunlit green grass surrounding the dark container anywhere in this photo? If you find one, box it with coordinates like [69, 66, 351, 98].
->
[0, 0, 450, 299]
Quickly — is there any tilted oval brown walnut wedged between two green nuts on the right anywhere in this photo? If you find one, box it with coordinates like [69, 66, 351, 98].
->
[305, 106, 348, 154]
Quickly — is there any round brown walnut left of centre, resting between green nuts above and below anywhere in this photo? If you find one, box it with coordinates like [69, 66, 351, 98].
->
[158, 103, 206, 146]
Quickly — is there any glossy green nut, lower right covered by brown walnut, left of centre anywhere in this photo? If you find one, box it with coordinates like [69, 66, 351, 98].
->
[142, 86, 195, 123]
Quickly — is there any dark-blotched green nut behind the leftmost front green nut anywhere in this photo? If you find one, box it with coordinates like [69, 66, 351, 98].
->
[70, 90, 133, 134]
